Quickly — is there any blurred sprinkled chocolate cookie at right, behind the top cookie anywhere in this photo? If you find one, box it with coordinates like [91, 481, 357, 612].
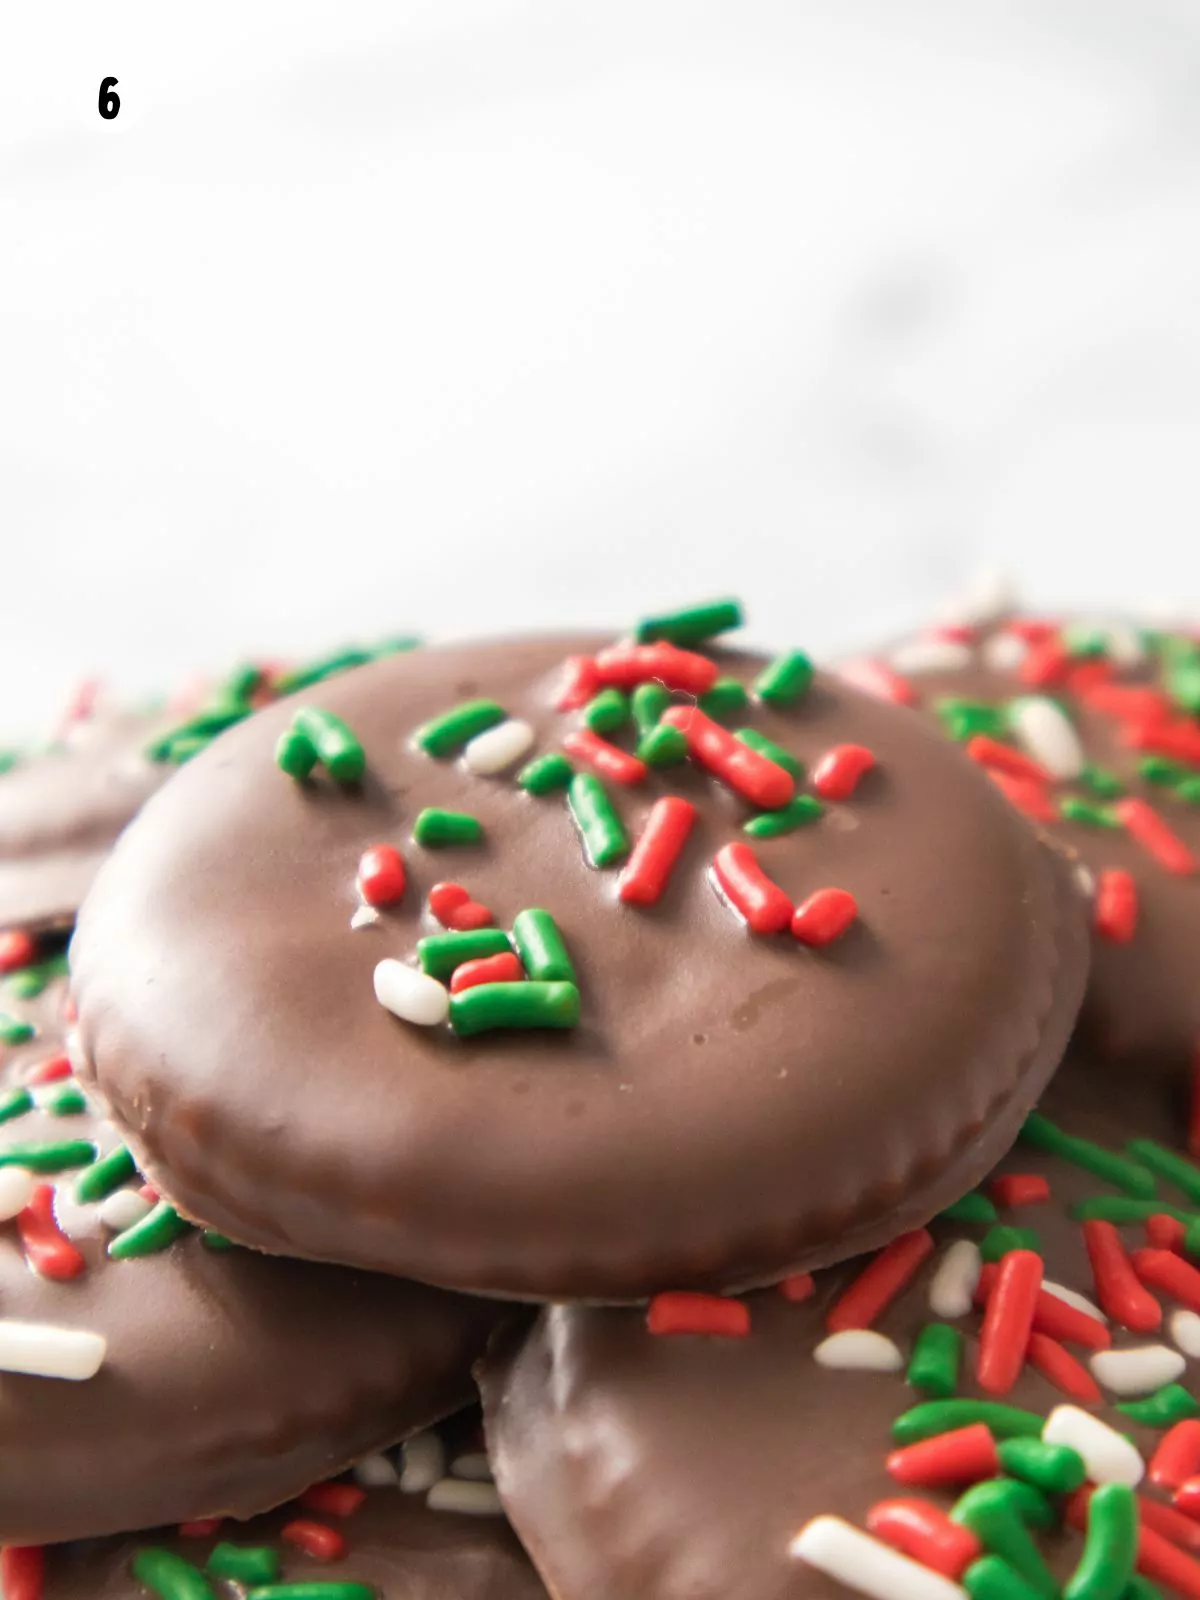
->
[848, 616, 1200, 1069]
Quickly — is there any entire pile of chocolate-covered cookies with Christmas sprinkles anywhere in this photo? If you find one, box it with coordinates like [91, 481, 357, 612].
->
[0, 600, 1200, 1600]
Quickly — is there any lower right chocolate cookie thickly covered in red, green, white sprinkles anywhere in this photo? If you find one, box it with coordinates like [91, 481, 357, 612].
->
[482, 1059, 1200, 1600]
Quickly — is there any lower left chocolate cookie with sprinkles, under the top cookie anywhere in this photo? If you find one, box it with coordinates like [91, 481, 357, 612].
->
[0, 979, 512, 1544]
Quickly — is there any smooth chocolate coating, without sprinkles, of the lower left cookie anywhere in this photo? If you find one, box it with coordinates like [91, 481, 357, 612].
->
[0, 994, 512, 1544]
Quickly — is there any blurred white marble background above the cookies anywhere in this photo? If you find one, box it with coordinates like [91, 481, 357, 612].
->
[0, 0, 1200, 728]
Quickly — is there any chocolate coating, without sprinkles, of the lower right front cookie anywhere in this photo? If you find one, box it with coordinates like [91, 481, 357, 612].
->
[482, 1061, 1200, 1600]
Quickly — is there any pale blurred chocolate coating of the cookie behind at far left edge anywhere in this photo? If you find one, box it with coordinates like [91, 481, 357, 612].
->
[0, 710, 171, 928]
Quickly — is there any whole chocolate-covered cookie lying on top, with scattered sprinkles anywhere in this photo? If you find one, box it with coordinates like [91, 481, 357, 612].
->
[72, 611, 1086, 1301]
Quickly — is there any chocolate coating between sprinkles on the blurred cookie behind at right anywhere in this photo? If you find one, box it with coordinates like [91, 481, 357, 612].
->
[851, 621, 1200, 1070]
